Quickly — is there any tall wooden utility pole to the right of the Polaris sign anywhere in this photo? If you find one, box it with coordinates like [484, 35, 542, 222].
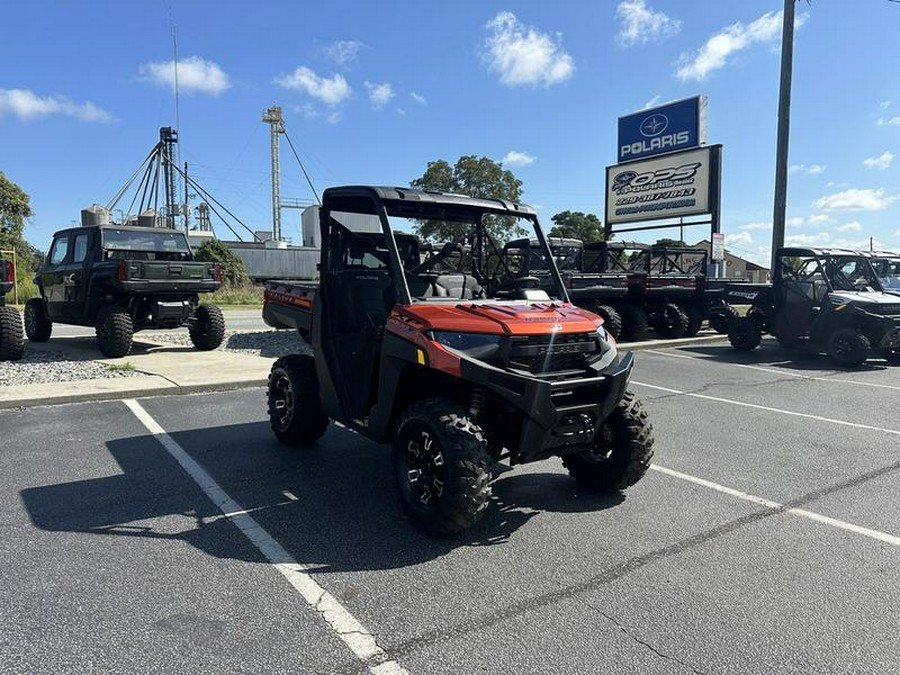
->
[771, 0, 796, 274]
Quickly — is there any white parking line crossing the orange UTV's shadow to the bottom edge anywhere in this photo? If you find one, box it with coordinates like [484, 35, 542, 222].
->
[123, 399, 408, 675]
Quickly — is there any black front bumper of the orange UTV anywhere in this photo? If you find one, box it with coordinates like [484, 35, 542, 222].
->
[460, 352, 634, 463]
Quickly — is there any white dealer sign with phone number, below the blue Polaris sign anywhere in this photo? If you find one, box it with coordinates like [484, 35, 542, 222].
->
[606, 145, 722, 225]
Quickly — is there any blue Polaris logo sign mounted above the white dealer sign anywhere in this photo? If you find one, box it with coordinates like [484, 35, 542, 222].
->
[618, 96, 706, 164]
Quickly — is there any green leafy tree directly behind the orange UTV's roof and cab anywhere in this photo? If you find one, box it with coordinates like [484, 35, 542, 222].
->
[409, 155, 522, 241]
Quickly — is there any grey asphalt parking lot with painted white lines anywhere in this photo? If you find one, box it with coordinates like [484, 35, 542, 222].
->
[0, 340, 900, 675]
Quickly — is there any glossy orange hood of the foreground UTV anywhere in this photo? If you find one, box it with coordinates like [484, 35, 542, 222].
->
[399, 301, 602, 335]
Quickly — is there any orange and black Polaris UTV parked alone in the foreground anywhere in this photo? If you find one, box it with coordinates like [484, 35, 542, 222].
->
[263, 187, 653, 536]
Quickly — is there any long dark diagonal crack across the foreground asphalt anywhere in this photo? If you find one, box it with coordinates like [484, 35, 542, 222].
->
[385, 461, 900, 659]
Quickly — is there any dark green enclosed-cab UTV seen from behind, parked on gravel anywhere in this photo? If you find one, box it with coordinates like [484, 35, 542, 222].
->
[25, 225, 225, 358]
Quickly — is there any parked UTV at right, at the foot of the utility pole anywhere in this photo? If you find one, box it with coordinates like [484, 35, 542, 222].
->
[728, 248, 900, 368]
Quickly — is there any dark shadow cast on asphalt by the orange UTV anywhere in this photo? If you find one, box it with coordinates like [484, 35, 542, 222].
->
[21, 423, 624, 572]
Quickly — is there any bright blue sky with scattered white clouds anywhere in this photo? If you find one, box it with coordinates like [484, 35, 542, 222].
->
[0, 0, 900, 262]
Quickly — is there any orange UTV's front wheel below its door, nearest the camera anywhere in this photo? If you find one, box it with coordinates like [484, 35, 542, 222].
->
[392, 399, 491, 537]
